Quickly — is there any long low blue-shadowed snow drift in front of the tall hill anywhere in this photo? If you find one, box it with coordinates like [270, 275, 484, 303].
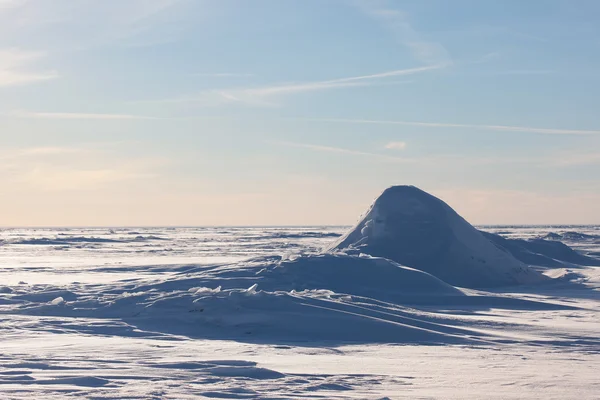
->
[7, 254, 565, 345]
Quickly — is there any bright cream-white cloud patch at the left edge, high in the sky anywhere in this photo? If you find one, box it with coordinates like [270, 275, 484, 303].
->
[0, 48, 58, 87]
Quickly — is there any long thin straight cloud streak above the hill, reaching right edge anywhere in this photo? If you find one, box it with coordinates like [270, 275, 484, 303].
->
[304, 118, 600, 135]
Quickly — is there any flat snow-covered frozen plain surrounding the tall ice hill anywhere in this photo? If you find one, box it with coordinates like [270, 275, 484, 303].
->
[0, 226, 600, 399]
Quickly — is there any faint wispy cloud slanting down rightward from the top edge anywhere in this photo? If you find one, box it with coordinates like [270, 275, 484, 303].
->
[355, 0, 452, 64]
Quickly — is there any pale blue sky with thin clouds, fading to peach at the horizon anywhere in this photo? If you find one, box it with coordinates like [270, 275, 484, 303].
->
[0, 0, 600, 226]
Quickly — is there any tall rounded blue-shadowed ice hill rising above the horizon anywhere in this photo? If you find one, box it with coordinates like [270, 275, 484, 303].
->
[327, 186, 547, 288]
